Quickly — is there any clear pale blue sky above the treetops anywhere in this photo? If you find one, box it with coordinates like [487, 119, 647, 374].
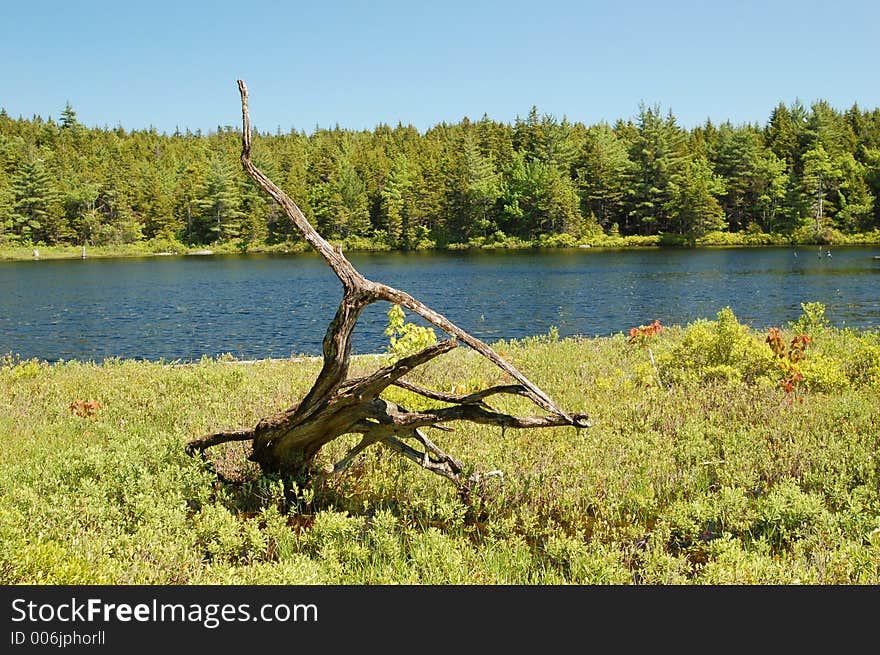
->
[0, 0, 880, 132]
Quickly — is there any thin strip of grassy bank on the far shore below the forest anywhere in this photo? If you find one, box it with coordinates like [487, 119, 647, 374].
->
[0, 230, 880, 260]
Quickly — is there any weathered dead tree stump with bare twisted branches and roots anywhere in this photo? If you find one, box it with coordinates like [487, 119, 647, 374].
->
[186, 80, 590, 489]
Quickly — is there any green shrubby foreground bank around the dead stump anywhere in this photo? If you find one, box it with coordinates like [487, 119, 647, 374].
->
[0, 305, 880, 585]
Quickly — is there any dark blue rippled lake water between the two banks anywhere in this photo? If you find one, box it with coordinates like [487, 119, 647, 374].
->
[0, 246, 880, 361]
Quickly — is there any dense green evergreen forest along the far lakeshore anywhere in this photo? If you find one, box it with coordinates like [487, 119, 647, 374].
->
[0, 101, 880, 249]
